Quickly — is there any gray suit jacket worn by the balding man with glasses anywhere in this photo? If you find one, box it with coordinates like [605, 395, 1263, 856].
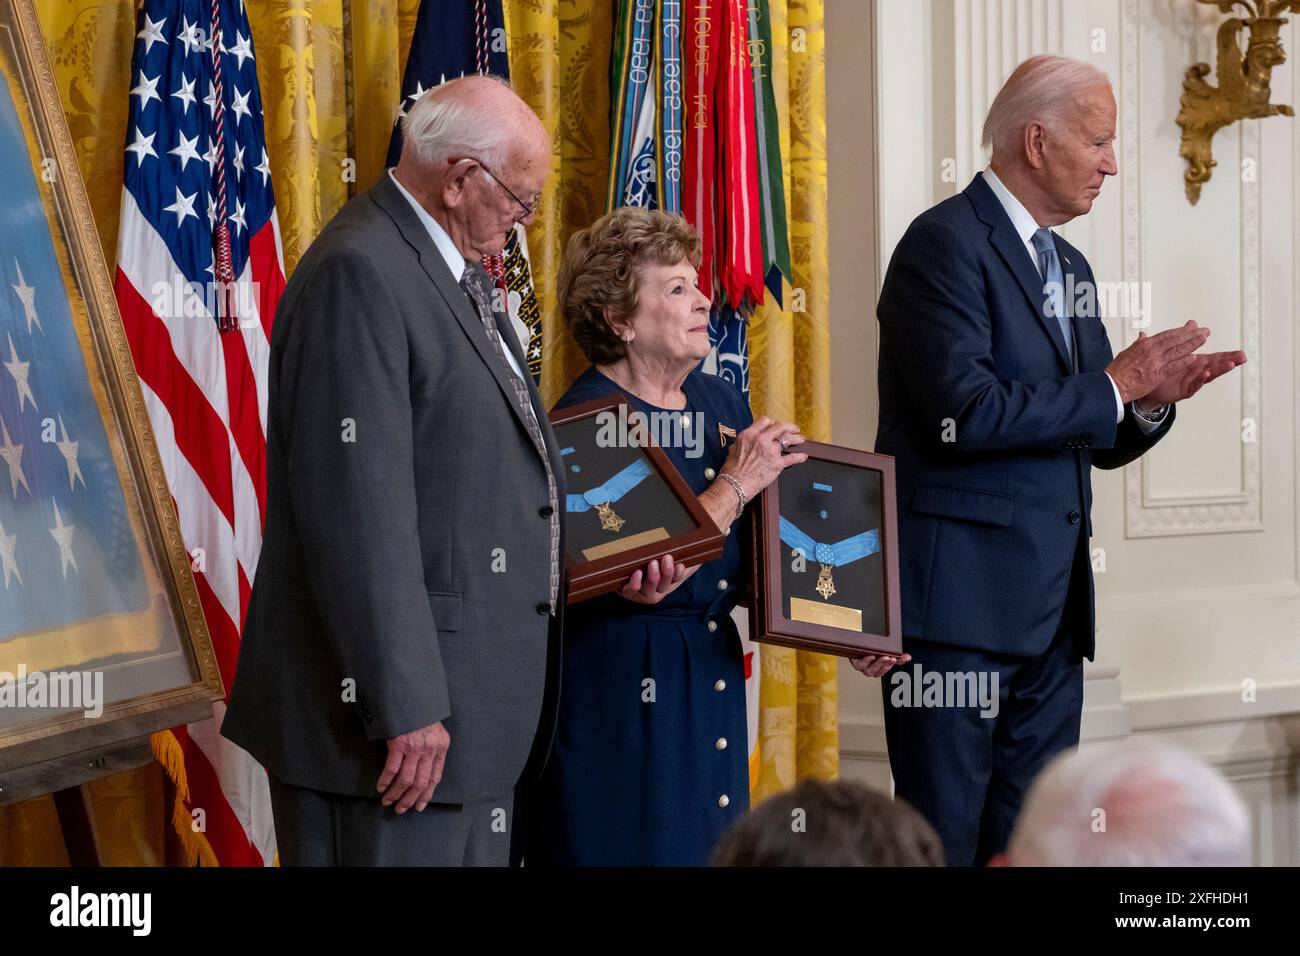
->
[222, 174, 564, 803]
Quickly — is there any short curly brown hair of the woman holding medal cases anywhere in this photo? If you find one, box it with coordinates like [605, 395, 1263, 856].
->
[558, 206, 701, 364]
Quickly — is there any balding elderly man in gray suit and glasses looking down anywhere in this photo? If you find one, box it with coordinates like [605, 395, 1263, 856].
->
[222, 77, 564, 865]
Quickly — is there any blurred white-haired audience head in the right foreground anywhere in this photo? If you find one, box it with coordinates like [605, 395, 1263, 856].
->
[1008, 737, 1251, 866]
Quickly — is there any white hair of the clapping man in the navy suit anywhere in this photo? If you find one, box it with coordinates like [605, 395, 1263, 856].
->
[982, 55, 1110, 156]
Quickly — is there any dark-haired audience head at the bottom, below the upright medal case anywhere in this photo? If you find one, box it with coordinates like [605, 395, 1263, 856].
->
[712, 780, 944, 866]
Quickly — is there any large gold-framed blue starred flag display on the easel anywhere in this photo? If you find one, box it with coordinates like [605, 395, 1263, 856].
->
[0, 0, 224, 803]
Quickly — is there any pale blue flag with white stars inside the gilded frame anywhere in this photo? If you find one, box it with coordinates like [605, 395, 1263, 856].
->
[0, 67, 150, 634]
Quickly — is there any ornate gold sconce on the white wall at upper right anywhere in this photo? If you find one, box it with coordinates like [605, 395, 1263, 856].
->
[1177, 0, 1300, 206]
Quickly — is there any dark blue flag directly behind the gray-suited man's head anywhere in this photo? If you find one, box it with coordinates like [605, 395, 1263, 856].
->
[387, 0, 542, 382]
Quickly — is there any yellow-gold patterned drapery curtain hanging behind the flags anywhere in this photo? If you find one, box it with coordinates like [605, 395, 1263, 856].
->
[0, 0, 839, 865]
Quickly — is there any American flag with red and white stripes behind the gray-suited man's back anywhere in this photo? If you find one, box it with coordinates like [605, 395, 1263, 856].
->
[114, 0, 285, 865]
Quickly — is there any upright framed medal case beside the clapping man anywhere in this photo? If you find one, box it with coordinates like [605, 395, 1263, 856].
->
[750, 441, 902, 657]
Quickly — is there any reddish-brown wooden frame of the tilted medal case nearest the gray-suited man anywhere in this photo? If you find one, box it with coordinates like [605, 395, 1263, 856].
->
[550, 395, 725, 604]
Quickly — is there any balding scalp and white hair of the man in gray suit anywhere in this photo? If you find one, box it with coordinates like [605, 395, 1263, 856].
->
[402, 74, 541, 170]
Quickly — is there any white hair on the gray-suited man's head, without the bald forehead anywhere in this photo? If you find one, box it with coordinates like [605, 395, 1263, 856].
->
[402, 77, 516, 172]
